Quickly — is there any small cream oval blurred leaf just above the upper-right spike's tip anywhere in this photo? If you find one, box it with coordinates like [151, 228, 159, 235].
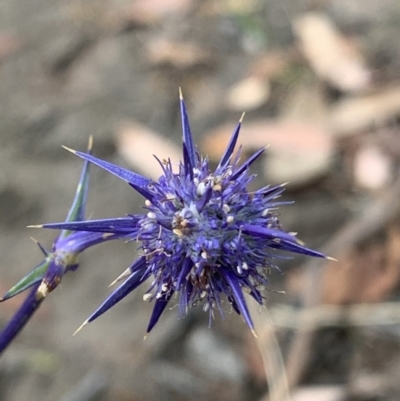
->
[227, 76, 270, 111]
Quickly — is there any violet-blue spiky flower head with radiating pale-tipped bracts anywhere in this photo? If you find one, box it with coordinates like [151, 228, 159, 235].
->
[44, 91, 325, 332]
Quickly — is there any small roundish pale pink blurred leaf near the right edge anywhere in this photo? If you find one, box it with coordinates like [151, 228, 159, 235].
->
[354, 145, 393, 190]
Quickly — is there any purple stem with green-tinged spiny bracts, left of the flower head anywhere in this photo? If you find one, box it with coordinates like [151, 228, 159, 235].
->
[0, 140, 123, 353]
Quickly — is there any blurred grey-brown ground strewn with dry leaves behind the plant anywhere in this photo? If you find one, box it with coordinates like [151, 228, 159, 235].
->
[0, 0, 400, 401]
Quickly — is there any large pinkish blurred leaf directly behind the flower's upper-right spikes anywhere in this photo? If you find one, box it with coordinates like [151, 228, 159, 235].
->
[202, 120, 334, 186]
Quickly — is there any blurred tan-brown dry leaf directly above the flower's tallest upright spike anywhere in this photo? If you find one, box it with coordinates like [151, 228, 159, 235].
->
[147, 39, 213, 69]
